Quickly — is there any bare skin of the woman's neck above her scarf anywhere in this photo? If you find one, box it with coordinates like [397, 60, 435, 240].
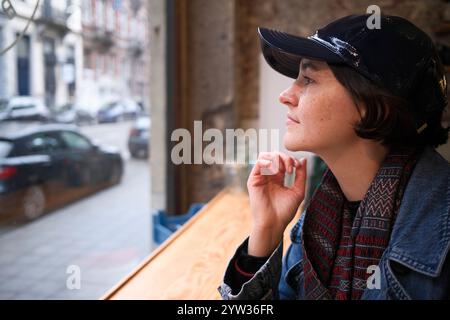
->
[319, 140, 389, 201]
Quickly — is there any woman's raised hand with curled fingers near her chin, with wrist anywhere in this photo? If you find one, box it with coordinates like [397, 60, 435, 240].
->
[247, 152, 306, 257]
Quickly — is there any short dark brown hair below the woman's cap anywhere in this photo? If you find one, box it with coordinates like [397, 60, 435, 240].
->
[329, 64, 450, 147]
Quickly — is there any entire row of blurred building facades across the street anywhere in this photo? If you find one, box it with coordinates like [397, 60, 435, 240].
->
[0, 0, 150, 112]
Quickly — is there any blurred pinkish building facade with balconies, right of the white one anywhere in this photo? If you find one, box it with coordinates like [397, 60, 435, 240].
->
[80, 0, 149, 112]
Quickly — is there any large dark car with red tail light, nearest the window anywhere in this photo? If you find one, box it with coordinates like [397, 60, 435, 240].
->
[0, 122, 123, 220]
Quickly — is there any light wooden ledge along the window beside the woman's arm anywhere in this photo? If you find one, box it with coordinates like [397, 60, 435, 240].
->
[102, 189, 302, 300]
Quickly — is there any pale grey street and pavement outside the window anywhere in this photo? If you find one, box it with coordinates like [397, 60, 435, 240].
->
[0, 122, 153, 299]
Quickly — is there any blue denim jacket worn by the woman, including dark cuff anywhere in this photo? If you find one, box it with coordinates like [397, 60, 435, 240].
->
[219, 148, 450, 300]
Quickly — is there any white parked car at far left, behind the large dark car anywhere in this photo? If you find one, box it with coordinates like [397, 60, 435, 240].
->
[0, 97, 51, 121]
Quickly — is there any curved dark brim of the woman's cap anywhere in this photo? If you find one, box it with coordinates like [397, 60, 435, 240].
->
[258, 28, 344, 79]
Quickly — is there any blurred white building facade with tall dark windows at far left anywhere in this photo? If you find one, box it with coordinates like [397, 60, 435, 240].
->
[0, 0, 83, 108]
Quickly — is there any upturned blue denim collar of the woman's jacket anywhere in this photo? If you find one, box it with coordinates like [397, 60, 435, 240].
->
[387, 148, 450, 277]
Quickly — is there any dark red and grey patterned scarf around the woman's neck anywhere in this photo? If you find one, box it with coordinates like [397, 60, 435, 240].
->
[302, 148, 420, 300]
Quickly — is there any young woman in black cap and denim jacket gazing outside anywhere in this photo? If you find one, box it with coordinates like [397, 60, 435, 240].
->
[219, 15, 450, 300]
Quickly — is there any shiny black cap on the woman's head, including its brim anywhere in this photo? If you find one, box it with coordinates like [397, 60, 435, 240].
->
[258, 15, 447, 128]
